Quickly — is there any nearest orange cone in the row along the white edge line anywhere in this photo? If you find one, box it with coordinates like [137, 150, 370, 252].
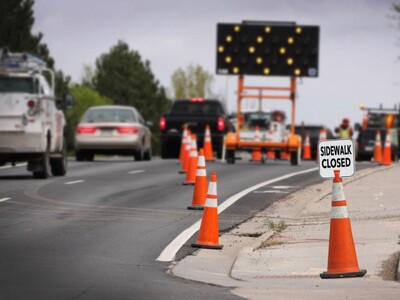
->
[192, 173, 223, 249]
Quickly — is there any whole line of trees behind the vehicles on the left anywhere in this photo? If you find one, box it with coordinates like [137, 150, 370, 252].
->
[0, 0, 219, 154]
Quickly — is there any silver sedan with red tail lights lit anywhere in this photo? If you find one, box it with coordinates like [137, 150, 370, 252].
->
[75, 105, 152, 161]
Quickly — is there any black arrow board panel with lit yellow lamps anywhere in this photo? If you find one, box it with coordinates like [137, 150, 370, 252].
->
[216, 22, 319, 77]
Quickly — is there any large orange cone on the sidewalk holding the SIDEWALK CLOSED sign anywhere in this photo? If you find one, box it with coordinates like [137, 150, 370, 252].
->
[320, 170, 367, 279]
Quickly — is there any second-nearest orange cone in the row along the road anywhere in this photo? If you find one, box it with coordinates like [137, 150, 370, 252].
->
[188, 148, 207, 209]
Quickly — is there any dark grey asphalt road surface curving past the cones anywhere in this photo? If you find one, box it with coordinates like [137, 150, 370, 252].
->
[0, 159, 368, 300]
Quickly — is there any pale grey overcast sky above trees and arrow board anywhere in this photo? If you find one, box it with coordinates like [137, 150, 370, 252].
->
[34, 0, 400, 128]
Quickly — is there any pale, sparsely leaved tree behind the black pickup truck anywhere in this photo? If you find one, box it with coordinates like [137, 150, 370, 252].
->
[171, 64, 216, 99]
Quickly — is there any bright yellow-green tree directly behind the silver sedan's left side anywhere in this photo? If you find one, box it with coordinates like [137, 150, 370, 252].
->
[66, 85, 112, 149]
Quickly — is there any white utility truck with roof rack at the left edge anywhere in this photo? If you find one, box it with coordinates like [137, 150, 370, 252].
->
[0, 49, 72, 178]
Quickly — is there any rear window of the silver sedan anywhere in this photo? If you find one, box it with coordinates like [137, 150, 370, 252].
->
[82, 108, 136, 123]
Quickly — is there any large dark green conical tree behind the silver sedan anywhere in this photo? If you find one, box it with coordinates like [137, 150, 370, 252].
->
[92, 41, 170, 153]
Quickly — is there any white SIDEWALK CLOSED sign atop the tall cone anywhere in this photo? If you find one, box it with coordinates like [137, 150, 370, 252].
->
[318, 139, 355, 178]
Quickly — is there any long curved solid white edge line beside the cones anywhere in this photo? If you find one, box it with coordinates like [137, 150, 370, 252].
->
[156, 167, 318, 261]
